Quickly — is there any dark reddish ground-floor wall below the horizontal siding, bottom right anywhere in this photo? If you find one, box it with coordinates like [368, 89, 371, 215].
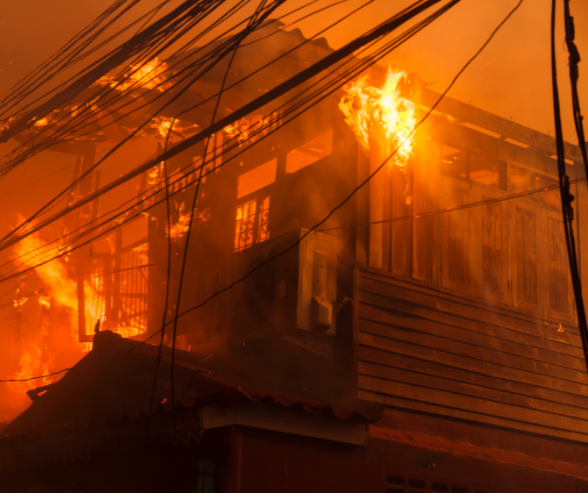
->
[224, 429, 588, 493]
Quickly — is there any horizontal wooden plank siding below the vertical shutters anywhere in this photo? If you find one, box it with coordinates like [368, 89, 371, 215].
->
[354, 268, 588, 442]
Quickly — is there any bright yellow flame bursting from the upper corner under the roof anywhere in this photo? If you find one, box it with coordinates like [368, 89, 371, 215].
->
[339, 69, 416, 167]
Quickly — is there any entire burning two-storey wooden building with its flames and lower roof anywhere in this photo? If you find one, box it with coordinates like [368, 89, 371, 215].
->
[0, 10, 588, 493]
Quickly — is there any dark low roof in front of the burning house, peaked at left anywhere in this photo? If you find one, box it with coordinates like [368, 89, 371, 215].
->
[0, 331, 382, 445]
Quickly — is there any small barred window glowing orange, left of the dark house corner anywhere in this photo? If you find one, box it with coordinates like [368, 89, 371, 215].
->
[235, 197, 269, 252]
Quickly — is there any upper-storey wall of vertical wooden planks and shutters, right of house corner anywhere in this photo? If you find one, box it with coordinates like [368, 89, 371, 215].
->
[370, 133, 576, 324]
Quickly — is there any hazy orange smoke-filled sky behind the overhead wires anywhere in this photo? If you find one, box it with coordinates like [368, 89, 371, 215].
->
[0, 0, 588, 234]
